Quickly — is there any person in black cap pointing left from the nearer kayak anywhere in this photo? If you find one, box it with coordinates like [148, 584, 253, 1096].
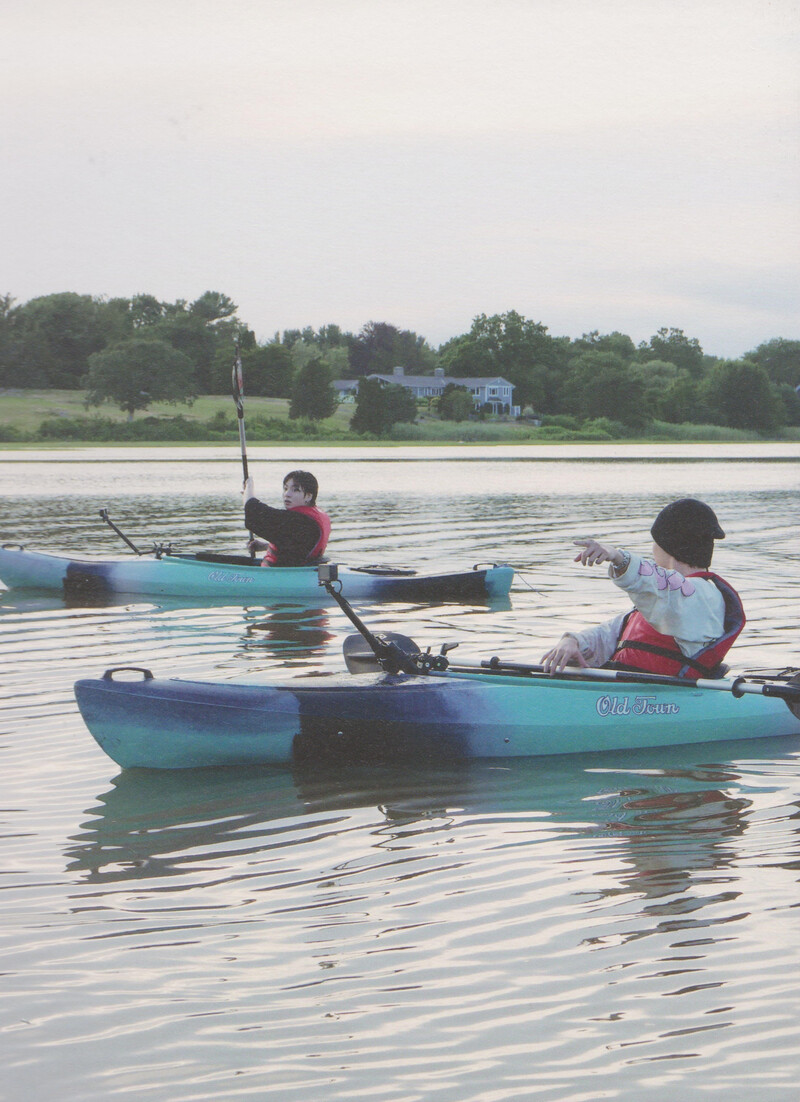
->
[541, 497, 745, 678]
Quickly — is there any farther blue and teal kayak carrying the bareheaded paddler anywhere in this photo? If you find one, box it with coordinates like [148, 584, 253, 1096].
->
[0, 545, 513, 604]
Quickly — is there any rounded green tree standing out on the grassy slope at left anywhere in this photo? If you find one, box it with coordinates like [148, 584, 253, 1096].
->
[82, 337, 195, 421]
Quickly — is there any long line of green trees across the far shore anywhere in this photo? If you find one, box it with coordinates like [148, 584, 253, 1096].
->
[0, 291, 800, 435]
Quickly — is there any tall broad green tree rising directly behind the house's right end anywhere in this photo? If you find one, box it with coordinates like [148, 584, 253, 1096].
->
[440, 310, 570, 412]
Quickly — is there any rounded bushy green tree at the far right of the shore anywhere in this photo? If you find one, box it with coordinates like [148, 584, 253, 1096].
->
[701, 359, 785, 433]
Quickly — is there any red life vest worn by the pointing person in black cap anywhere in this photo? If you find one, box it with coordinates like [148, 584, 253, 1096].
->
[612, 571, 745, 678]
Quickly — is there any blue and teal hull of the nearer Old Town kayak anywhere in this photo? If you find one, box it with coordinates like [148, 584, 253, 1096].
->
[75, 671, 800, 769]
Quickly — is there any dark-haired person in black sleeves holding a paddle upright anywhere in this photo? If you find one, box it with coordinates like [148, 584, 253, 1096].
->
[242, 471, 331, 566]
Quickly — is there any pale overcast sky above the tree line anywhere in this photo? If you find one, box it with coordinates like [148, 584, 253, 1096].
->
[0, 0, 800, 356]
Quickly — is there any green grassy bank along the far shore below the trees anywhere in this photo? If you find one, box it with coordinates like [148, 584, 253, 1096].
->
[0, 389, 800, 440]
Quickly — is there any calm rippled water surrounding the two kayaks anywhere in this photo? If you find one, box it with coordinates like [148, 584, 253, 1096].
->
[0, 446, 800, 1102]
